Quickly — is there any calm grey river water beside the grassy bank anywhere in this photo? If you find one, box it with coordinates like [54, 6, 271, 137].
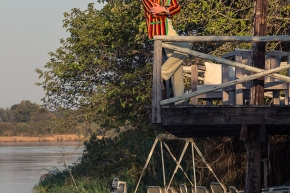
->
[0, 142, 83, 193]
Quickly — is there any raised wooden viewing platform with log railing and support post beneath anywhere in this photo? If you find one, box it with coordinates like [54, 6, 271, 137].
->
[150, 36, 290, 193]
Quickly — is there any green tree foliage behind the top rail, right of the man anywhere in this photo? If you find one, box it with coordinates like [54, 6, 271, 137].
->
[177, 0, 290, 55]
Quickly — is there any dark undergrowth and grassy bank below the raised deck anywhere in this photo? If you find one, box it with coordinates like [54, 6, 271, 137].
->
[37, 128, 290, 192]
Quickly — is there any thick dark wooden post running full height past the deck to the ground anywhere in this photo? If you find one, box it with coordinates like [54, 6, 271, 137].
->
[245, 0, 268, 193]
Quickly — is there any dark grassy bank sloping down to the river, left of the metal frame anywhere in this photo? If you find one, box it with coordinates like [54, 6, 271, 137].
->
[34, 129, 162, 193]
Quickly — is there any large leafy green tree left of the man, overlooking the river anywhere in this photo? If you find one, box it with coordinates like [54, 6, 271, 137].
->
[37, 1, 152, 129]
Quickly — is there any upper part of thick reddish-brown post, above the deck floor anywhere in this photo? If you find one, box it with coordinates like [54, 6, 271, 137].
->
[250, 0, 268, 105]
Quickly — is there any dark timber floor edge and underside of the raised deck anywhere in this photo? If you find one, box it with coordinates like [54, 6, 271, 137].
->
[151, 105, 290, 137]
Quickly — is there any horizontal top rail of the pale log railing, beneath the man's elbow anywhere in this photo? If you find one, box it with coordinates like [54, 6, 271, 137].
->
[154, 35, 290, 42]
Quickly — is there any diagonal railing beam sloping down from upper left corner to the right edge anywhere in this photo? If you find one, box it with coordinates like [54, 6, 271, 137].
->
[162, 43, 290, 82]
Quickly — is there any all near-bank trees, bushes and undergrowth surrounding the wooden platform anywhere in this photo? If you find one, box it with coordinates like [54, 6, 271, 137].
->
[32, 0, 290, 192]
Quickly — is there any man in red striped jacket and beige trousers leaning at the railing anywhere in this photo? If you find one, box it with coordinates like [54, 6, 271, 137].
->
[142, 0, 190, 100]
